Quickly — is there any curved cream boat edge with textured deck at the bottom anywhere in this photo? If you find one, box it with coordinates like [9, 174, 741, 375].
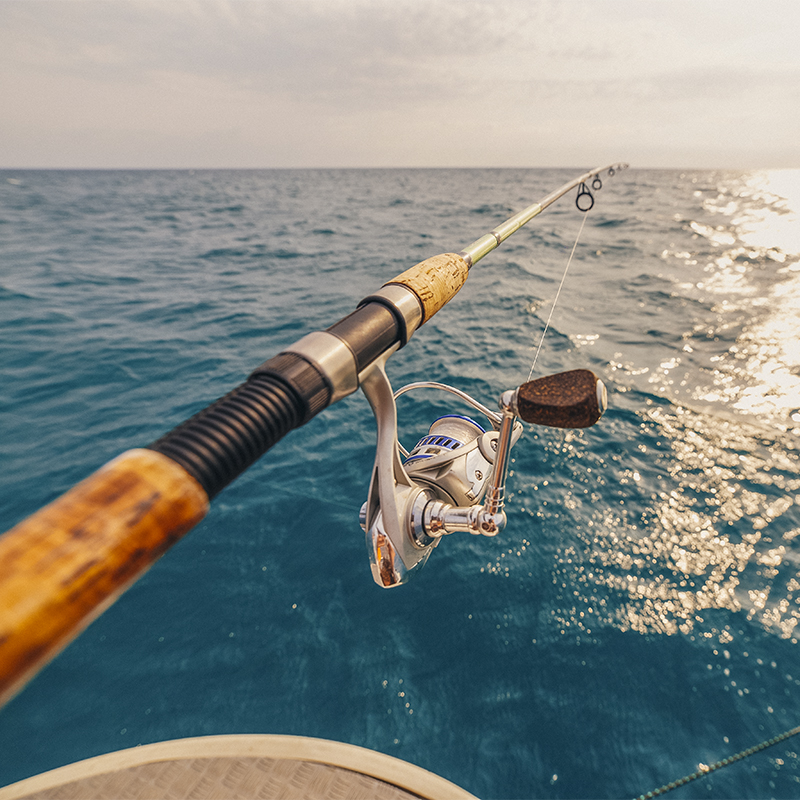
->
[0, 736, 474, 800]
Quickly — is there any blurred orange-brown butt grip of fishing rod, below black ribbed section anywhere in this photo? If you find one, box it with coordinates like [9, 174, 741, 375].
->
[0, 450, 208, 703]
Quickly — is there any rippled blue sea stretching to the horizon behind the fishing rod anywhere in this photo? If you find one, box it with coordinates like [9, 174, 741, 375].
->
[0, 169, 800, 798]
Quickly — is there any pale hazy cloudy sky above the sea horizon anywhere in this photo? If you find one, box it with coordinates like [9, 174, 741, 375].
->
[0, 0, 800, 169]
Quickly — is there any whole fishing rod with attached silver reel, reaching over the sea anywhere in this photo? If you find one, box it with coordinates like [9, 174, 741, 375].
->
[0, 164, 627, 703]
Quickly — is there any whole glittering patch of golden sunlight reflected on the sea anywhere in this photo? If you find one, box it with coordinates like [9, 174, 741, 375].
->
[548, 170, 800, 643]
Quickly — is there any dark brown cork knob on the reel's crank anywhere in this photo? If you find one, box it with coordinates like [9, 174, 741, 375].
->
[513, 369, 608, 428]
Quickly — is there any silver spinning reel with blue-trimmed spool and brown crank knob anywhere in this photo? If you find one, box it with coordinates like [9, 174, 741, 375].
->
[359, 356, 606, 588]
